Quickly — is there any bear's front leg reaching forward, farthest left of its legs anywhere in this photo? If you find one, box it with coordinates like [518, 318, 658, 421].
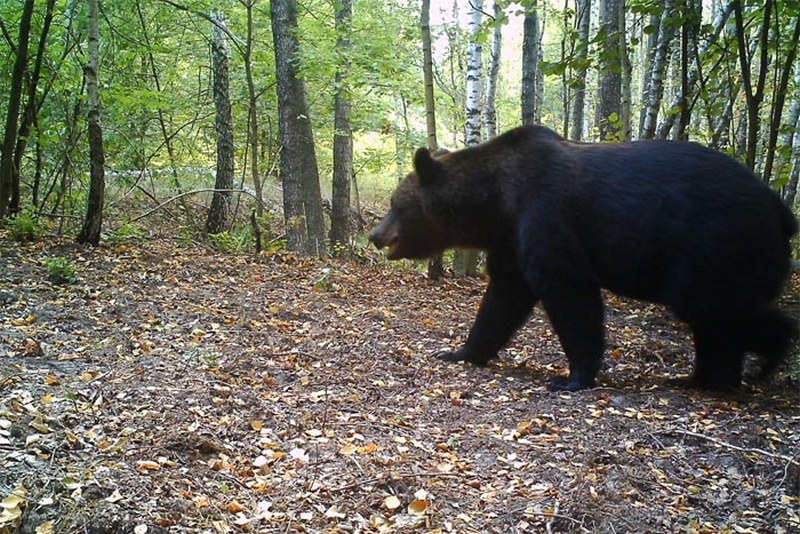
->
[434, 255, 537, 366]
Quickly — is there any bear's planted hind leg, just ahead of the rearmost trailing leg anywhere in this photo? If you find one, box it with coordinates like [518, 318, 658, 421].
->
[689, 317, 745, 391]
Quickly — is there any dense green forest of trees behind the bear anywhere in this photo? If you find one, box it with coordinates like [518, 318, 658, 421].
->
[0, 0, 800, 262]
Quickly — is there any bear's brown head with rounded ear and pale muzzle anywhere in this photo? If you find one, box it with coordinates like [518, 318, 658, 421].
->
[369, 148, 452, 260]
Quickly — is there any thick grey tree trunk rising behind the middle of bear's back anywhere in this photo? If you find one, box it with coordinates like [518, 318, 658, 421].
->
[596, 0, 625, 140]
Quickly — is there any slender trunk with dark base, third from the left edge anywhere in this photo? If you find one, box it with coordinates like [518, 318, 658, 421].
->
[78, 0, 105, 245]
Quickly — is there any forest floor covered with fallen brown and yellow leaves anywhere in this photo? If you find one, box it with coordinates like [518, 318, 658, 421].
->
[0, 240, 800, 534]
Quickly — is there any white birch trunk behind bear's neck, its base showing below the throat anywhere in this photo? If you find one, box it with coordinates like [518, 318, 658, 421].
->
[453, 0, 483, 276]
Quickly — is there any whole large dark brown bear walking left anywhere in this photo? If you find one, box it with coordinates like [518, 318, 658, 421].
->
[370, 126, 797, 391]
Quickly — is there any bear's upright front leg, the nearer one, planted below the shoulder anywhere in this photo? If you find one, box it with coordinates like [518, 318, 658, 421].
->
[542, 280, 605, 391]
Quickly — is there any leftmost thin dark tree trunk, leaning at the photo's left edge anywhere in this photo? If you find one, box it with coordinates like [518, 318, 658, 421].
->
[0, 0, 34, 219]
